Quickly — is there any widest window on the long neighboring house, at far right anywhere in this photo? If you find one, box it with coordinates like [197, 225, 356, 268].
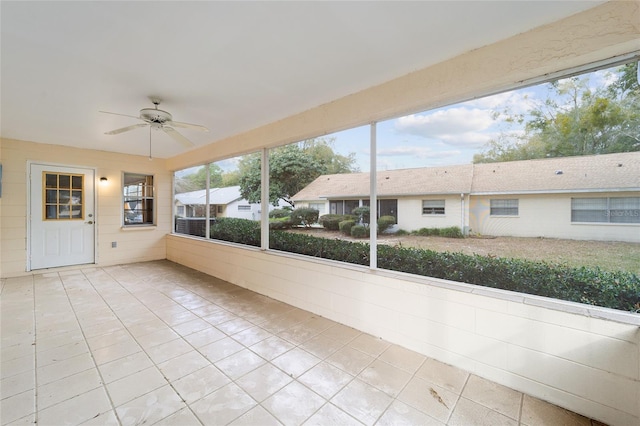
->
[571, 197, 640, 223]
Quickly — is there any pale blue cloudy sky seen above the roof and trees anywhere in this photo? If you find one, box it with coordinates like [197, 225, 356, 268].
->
[184, 63, 615, 176]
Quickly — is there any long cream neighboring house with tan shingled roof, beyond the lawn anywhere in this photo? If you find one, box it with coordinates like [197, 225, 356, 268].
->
[293, 152, 640, 242]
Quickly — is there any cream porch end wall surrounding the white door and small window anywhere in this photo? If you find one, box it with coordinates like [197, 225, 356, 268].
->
[0, 139, 172, 277]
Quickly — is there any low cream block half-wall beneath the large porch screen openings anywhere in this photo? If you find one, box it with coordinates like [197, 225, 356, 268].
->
[167, 235, 640, 425]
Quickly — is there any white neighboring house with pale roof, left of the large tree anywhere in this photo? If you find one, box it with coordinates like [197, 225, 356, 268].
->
[174, 186, 260, 220]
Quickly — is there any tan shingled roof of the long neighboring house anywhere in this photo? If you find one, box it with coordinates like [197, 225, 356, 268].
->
[293, 152, 640, 201]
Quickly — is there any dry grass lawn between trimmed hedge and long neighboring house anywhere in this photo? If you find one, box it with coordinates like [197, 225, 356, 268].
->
[290, 228, 640, 274]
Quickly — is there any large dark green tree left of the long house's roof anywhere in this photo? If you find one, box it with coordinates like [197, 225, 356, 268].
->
[238, 138, 358, 207]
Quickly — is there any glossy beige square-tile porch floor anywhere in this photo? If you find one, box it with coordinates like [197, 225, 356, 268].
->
[0, 261, 598, 426]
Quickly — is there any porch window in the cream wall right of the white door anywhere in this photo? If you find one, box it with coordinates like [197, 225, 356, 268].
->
[123, 173, 155, 226]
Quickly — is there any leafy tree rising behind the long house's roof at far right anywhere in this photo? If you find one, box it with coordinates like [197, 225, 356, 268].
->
[474, 63, 640, 163]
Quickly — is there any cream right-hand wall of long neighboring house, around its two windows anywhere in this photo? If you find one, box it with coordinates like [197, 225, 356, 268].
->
[469, 192, 640, 243]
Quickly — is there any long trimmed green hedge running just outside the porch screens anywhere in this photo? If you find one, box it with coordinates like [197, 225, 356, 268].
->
[211, 218, 640, 311]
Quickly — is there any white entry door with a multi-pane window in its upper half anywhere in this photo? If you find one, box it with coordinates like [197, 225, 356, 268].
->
[28, 164, 95, 269]
